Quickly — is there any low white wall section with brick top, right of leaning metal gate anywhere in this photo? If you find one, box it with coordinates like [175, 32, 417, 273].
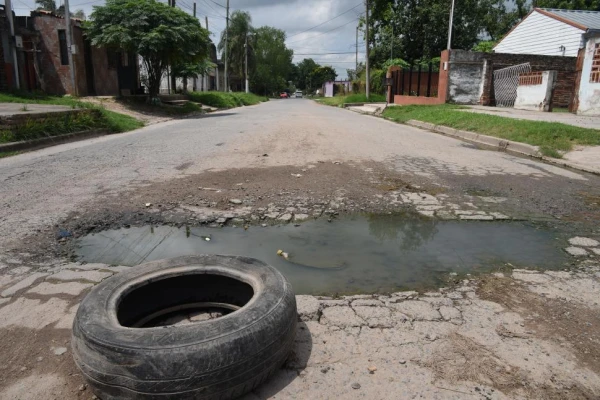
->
[514, 71, 556, 111]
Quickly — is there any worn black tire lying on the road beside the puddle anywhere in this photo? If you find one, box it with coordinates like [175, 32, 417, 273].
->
[72, 255, 297, 400]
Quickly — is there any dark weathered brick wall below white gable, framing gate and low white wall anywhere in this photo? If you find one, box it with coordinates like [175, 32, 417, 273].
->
[478, 50, 577, 107]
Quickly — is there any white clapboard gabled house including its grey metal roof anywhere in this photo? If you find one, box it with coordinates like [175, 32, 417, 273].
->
[494, 8, 600, 57]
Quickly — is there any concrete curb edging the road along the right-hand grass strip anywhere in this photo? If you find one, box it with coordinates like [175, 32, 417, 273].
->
[405, 119, 600, 175]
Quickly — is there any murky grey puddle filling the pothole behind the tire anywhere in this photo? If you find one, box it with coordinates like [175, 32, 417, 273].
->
[76, 215, 567, 294]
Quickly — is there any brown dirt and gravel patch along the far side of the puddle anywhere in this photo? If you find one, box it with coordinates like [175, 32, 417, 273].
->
[20, 162, 446, 259]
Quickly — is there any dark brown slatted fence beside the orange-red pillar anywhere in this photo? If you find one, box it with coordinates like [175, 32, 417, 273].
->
[392, 63, 440, 97]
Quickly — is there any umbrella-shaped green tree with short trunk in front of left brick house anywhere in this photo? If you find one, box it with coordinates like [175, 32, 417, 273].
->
[85, 0, 210, 103]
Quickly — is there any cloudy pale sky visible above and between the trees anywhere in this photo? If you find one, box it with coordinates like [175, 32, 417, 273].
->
[13, 0, 365, 79]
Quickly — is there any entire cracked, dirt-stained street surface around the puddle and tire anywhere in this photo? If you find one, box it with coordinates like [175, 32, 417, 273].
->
[0, 99, 600, 400]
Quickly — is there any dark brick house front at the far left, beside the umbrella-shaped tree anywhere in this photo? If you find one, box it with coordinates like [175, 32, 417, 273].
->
[0, 8, 140, 96]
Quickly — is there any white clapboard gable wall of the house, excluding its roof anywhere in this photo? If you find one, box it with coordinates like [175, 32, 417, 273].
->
[494, 10, 584, 57]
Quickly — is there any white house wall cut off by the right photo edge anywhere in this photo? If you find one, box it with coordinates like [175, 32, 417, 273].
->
[577, 36, 600, 116]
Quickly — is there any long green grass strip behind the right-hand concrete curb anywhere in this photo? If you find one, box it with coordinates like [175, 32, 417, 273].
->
[383, 104, 600, 158]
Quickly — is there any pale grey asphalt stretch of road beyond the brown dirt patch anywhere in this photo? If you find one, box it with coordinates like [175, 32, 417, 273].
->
[0, 99, 600, 248]
